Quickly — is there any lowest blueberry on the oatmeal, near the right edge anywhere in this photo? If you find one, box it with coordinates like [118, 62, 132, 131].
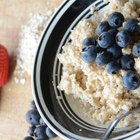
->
[123, 71, 140, 90]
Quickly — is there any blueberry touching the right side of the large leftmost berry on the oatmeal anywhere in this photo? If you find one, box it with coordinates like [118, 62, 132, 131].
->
[95, 51, 112, 66]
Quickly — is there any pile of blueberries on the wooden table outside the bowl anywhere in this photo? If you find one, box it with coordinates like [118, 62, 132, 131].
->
[24, 101, 57, 140]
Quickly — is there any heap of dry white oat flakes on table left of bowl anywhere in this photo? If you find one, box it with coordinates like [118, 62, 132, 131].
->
[14, 11, 53, 84]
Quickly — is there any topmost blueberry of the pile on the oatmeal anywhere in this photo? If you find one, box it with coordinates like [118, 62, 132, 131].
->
[108, 12, 124, 28]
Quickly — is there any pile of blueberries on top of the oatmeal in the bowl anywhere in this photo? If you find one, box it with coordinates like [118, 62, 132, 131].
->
[81, 12, 140, 90]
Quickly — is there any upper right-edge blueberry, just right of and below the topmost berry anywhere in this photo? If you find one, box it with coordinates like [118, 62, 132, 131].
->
[124, 19, 140, 35]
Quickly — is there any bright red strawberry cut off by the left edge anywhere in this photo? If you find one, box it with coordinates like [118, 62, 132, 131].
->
[0, 44, 9, 87]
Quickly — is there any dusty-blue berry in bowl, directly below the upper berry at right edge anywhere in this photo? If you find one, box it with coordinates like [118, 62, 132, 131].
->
[116, 31, 131, 48]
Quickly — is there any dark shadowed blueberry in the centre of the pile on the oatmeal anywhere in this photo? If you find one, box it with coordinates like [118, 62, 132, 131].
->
[107, 43, 122, 59]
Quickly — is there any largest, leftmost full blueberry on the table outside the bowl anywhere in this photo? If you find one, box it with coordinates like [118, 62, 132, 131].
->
[26, 109, 40, 125]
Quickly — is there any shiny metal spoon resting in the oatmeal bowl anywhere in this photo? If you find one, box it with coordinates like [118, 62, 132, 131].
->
[100, 106, 140, 140]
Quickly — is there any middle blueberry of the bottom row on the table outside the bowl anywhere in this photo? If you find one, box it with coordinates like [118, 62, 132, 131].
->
[34, 126, 48, 139]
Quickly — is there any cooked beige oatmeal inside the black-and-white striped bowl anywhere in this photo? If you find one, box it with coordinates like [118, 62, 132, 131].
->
[58, 0, 140, 126]
